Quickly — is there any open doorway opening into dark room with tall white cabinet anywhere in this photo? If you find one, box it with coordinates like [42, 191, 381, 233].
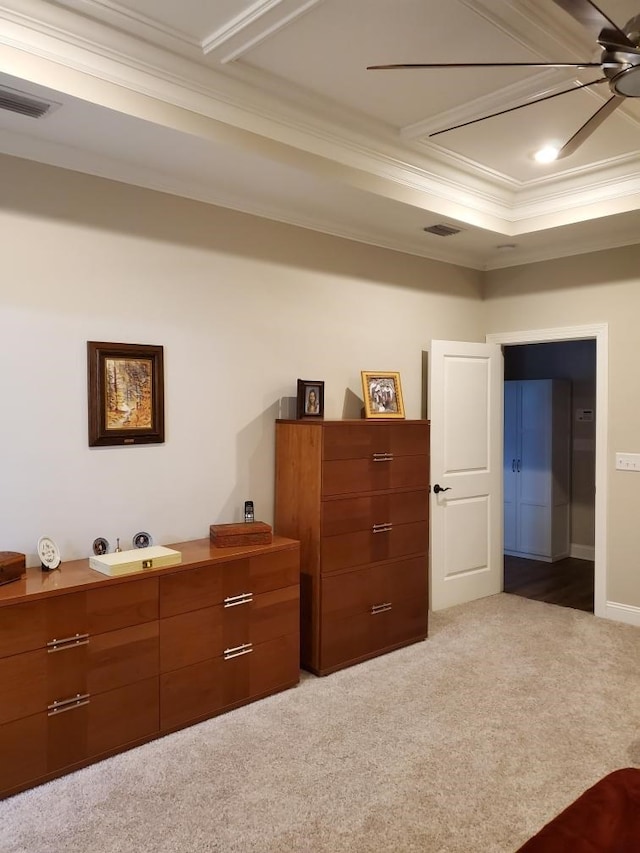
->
[503, 339, 596, 613]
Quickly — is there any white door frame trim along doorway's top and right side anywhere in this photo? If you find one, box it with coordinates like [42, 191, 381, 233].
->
[486, 323, 608, 619]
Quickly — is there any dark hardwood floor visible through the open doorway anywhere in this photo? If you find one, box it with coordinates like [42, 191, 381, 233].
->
[504, 554, 593, 613]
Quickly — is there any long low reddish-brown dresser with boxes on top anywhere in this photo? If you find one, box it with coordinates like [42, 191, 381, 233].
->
[0, 536, 300, 796]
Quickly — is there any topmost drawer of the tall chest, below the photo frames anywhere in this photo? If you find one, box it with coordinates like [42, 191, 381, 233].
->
[322, 421, 429, 462]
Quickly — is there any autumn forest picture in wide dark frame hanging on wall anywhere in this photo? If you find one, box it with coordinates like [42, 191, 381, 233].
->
[87, 341, 164, 447]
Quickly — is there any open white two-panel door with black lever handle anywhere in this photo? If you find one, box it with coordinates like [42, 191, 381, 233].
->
[429, 341, 504, 610]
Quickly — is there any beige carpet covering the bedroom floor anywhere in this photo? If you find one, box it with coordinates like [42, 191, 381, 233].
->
[0, 595, 640, 853]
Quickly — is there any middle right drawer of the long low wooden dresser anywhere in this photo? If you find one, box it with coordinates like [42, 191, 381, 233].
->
[160, 585, 300, 672]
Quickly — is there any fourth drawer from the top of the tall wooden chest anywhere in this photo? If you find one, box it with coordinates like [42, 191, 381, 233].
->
[320, 521, 429, 574]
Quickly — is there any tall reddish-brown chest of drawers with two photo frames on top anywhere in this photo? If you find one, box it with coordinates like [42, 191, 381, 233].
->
[275, 420, 429, 675]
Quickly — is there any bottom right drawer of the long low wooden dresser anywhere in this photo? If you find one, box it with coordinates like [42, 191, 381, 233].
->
[160, 632, 300, 731]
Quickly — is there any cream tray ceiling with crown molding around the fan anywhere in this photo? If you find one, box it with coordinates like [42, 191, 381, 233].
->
[0, 0, 640, 269]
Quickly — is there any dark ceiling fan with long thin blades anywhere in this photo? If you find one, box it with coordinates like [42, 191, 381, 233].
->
[367, 0, 640, 159]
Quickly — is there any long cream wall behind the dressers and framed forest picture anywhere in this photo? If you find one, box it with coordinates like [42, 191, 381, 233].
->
[0, 157, 484, 564]
